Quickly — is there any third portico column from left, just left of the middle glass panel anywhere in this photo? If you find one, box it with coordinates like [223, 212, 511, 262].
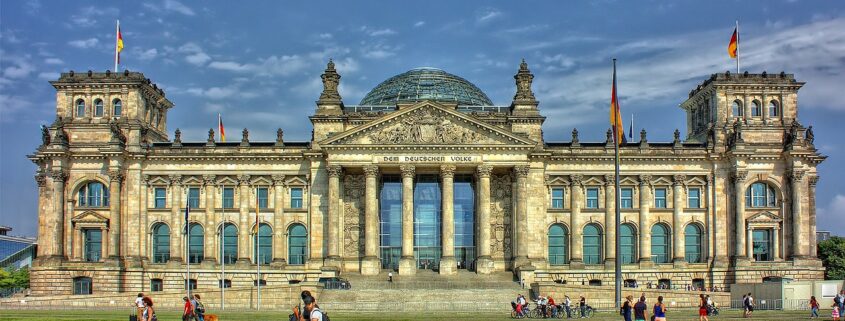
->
[399, 165, 417, 275]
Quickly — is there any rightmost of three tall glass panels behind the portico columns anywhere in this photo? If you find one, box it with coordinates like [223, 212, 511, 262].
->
[453, 175, 475, 270]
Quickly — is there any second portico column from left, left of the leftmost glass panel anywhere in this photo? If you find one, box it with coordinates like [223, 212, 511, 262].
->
[361, 165, 381, 275]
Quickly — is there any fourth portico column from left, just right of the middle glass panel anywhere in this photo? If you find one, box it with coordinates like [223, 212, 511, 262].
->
[440, 165, 458, 275]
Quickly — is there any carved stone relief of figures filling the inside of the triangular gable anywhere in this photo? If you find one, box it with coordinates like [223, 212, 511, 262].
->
[370, 108, 495, 144]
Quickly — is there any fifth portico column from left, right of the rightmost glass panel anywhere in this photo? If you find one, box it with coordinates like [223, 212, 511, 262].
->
[475, 165, 494, 274]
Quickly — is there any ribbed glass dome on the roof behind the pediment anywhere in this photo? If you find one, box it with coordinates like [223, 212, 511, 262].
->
[359, 67, 493, 106]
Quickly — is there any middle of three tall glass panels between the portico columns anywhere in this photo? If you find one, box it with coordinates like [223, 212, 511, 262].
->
[414, 174, 442, 269]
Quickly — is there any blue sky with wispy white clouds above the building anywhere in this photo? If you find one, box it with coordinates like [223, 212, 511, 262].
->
[0, 0, 845, 236]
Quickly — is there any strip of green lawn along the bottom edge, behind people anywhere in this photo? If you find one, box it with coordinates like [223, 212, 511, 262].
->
[0, 309, 830, 321]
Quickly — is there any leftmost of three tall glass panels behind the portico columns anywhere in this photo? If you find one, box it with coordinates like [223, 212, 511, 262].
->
[379, 175, 402, 270]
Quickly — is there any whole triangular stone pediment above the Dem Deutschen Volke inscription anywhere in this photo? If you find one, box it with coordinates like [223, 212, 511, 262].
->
[320, 101, 536, 147]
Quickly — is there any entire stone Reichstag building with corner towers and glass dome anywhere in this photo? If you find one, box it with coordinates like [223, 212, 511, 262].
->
[28, 61, 825, 294]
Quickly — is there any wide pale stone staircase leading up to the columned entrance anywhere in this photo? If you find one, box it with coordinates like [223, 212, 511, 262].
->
[318, 270, 529, 313]
